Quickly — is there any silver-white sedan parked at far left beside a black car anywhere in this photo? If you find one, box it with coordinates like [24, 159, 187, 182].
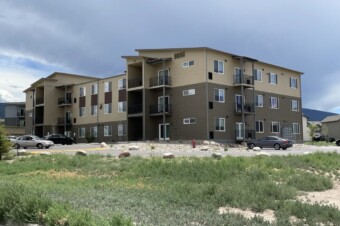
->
[11, 135, 54, 149]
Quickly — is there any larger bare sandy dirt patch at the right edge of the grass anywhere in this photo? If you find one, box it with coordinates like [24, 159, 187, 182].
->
[298, 181, 340, 210]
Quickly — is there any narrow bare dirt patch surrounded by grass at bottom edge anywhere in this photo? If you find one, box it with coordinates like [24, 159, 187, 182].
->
[218, 207, 276, 223]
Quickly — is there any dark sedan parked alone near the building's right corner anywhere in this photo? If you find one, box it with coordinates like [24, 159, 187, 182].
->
[247, 136, 293, 150]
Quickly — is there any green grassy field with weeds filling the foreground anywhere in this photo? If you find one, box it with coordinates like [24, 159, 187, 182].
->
[0, 153, 340, 225]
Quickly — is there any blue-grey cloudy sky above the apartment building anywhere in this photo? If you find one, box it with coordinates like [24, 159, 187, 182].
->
[0, 0, 340, 113]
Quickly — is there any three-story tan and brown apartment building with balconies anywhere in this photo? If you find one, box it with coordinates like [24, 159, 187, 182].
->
[25, 47, 303, 142]
